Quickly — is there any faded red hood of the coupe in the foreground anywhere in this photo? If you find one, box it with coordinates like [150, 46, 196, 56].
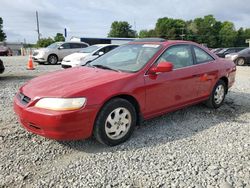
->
[20, 67, 132, 100]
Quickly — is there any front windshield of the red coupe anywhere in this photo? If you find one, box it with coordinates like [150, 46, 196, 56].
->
[90, 44, 161, 72]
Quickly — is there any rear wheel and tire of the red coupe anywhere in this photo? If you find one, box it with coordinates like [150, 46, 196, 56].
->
[206, 80, 227, 109]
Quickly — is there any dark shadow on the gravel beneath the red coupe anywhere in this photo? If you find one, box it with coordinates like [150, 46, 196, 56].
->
[60, 91, 250, 153]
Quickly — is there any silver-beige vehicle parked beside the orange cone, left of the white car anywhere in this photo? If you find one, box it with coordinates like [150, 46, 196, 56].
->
[32, 42, 89, 64]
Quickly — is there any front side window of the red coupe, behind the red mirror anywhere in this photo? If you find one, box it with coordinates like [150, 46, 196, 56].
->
[157, 45, 193, 69]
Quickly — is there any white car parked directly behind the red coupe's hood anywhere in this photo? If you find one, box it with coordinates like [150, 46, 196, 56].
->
[61, 44, 118, 69]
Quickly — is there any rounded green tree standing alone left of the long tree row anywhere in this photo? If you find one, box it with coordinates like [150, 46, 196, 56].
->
[108, 21, 136, 38]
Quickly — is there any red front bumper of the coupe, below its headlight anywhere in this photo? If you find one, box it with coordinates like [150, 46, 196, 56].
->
[14, 95, 98, 140]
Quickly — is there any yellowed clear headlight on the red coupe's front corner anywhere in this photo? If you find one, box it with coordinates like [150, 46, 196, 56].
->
[35, 98, 87, 111]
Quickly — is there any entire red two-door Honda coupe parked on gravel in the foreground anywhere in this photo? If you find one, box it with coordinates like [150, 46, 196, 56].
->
[14, 39, 236, 146]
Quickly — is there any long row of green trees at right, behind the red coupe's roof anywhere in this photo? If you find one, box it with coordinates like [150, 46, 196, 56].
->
[139, 15, 250, 48]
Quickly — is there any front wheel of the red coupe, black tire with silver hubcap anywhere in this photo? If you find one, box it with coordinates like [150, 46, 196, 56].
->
[94, 98, 137, 146]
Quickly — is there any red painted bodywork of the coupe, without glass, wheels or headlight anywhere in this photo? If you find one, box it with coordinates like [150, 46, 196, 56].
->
[14, 41, 236, 140]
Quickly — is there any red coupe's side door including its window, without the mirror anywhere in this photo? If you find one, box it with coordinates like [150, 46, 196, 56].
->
[145, 44, 197, 116]
